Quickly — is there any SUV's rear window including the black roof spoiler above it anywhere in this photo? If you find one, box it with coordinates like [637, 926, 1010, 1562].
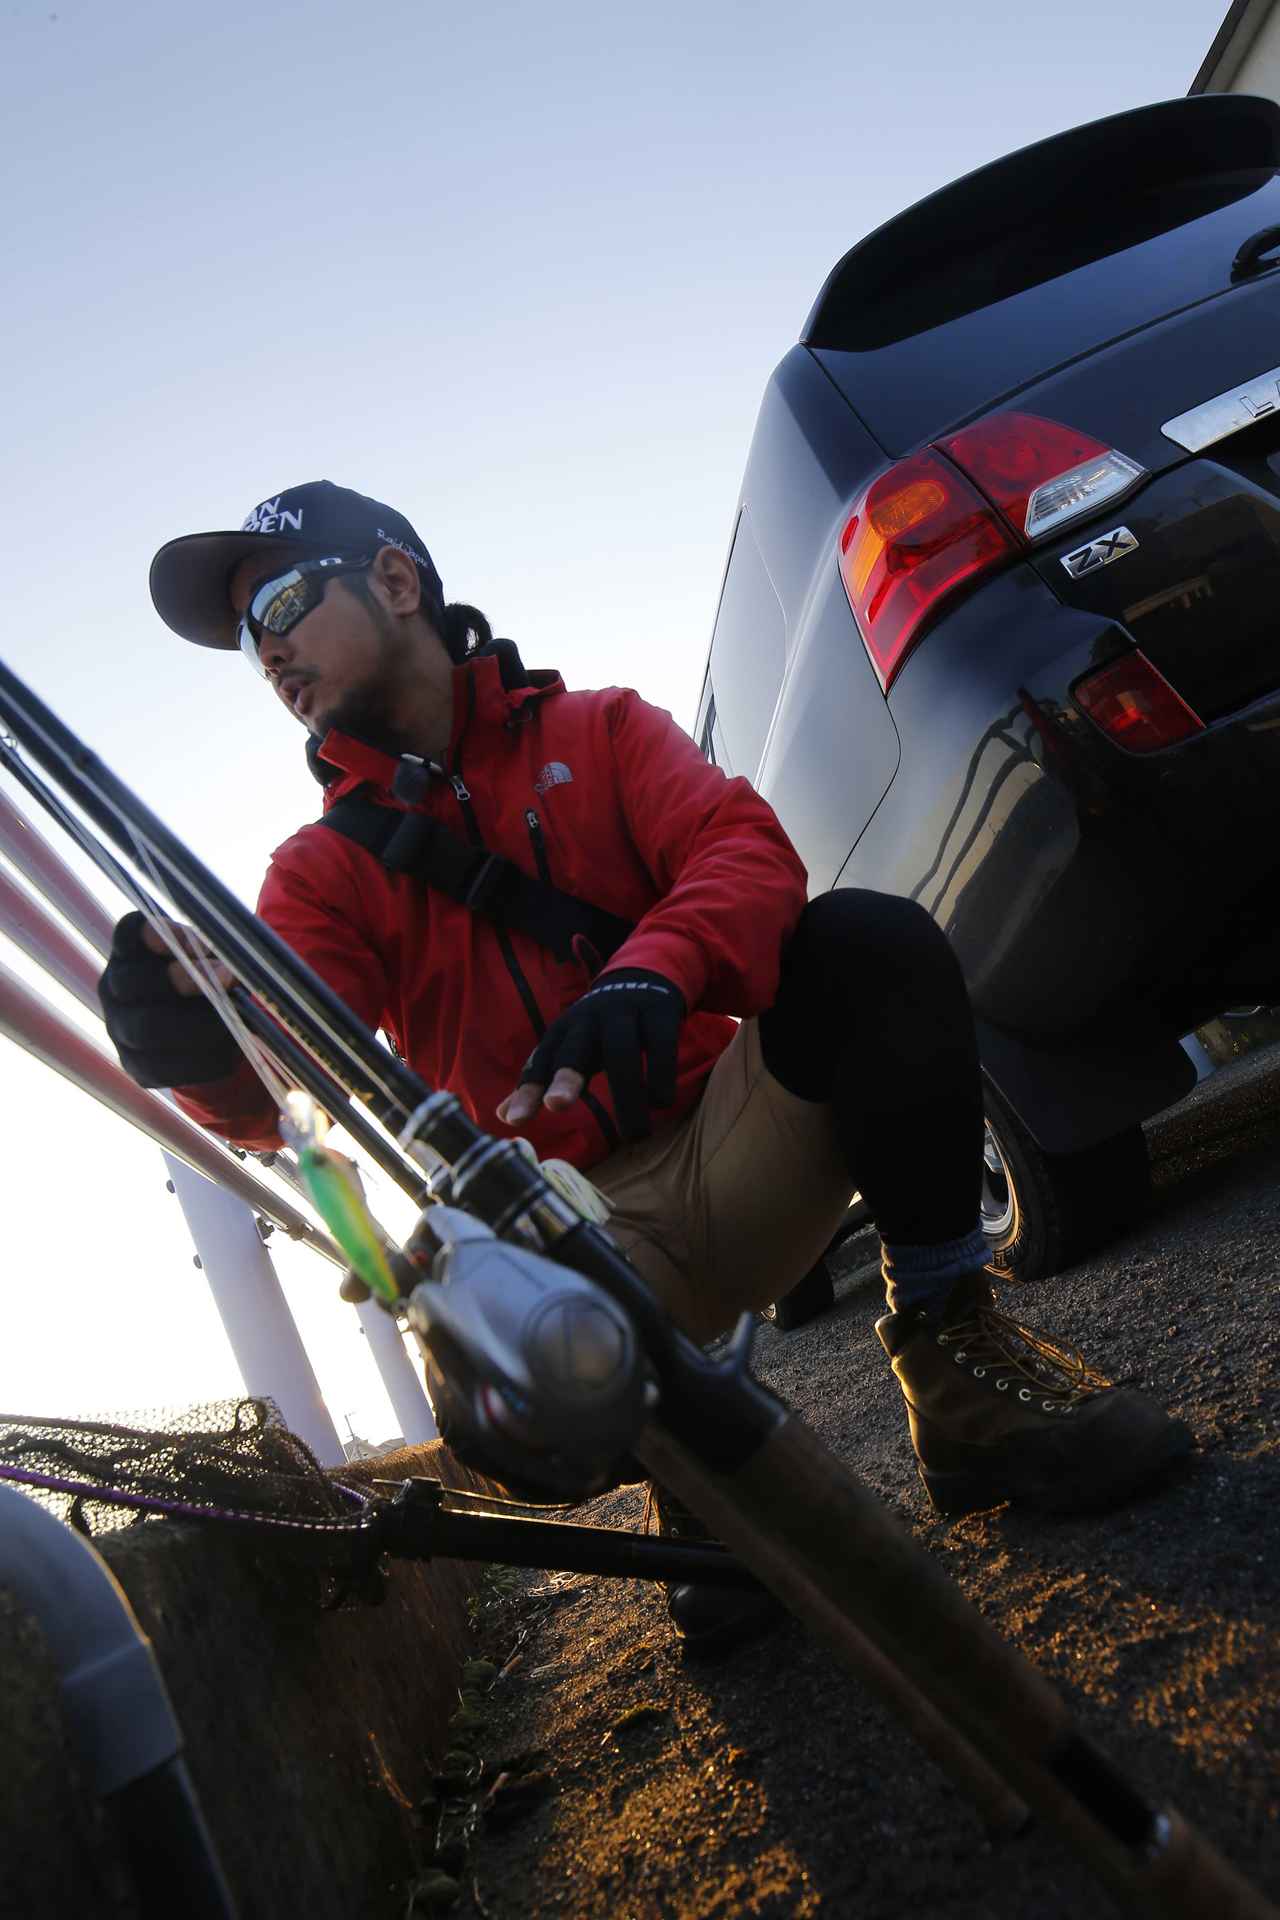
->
[804, 96, 1280, 453]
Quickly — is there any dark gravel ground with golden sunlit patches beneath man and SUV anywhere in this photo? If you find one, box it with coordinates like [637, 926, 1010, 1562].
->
[415, 1048, 1280, 1920]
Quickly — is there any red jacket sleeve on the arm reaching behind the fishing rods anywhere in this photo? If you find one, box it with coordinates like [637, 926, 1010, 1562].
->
[175, 828, 386, 1152]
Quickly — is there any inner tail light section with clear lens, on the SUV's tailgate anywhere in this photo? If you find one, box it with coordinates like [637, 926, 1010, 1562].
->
[940, 413, 1144, 540]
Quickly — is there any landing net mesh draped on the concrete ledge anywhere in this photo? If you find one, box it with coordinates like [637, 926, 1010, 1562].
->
[0, 1400, 372, 1536]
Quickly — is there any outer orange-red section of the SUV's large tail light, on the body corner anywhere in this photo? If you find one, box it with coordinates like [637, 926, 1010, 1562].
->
[841, 451, 1017, 693]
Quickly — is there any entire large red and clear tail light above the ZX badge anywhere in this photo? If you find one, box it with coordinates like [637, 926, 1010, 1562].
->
[841, 413, 1144, 693]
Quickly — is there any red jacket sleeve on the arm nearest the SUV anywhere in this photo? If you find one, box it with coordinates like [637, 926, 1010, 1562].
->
[594, 693, 806, 1020]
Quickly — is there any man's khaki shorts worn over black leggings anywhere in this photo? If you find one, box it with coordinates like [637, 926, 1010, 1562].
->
[589, 1020, 854, 1340]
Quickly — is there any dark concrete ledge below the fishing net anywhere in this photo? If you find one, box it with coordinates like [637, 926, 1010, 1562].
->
[0, 1442, 498, 1920]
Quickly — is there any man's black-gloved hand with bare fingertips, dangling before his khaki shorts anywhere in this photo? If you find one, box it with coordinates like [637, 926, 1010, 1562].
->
[497, 968, 685, 1140]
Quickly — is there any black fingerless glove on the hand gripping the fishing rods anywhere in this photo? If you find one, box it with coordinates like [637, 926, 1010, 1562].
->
[98, 914, 240, 1087]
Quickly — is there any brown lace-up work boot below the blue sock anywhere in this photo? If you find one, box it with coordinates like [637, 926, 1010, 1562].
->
[875, 1273, 1194, 1515]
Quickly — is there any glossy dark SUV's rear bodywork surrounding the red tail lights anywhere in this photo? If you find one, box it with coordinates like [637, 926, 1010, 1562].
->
[699, 102, 1280, 1154]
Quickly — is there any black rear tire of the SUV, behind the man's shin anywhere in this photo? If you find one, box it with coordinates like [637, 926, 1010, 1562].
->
[983, 1087, 1151, 1284]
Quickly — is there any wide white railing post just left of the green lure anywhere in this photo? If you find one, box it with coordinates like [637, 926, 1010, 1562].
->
[165, 1154, 345, 1467]
